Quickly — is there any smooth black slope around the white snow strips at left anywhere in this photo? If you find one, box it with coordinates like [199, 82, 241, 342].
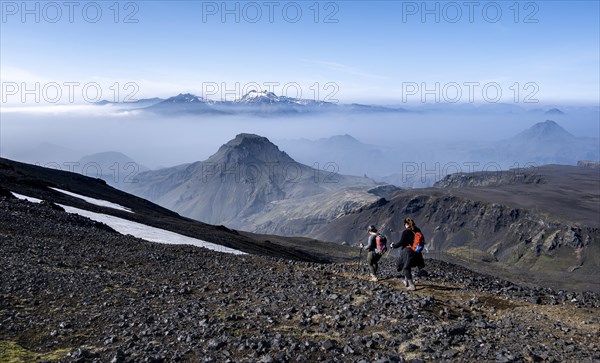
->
[0, 158, 347, 261]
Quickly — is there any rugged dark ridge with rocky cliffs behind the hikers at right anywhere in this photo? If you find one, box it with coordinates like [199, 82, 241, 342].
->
[313, 165, 600, 291]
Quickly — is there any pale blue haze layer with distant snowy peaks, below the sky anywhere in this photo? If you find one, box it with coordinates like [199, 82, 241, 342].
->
[0, 91, 600, 175]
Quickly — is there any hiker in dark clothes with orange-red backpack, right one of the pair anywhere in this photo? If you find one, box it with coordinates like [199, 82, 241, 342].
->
[390, 217, 425, 290]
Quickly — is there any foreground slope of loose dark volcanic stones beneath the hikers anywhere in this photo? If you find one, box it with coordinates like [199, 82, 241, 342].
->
[0, 197, 600, 362]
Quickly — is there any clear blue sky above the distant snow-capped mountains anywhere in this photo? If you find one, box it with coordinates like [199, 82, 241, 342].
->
[0, 1, 600, 105]
